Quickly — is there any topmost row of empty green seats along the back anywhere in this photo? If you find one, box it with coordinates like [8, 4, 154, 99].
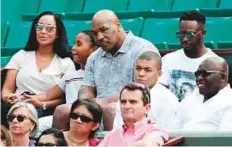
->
[1, 0, 232, 22]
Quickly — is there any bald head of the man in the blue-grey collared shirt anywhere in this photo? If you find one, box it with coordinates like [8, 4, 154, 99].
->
[92, 10, 126, 54]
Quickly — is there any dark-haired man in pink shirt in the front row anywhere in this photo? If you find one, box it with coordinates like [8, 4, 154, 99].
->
[99, 83, 168, 146]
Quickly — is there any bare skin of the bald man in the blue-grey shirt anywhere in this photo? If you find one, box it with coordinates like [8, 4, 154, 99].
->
[78, 10, 126, 130]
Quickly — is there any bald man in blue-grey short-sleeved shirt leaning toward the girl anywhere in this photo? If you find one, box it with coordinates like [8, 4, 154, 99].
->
[79, 10, 159, 130]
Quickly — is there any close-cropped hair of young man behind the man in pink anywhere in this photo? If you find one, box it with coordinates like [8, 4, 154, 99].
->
[137, 51, 162, 70]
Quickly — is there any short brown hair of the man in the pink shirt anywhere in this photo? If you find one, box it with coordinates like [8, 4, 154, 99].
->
[119, 82, 151, 106]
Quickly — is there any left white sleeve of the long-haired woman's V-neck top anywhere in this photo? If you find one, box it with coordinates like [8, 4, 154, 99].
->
[5, 50, 26, 70]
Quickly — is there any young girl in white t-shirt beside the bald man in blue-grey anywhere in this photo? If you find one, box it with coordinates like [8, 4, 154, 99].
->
[25, 30, 98, 134]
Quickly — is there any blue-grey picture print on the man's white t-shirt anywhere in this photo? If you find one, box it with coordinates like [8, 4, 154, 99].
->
[169, 70, 196, 101]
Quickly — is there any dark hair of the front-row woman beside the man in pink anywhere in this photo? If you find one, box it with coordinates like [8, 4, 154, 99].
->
[69, 99, 103, 138]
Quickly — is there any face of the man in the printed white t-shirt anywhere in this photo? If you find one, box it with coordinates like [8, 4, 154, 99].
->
[179, 20, 207, 58]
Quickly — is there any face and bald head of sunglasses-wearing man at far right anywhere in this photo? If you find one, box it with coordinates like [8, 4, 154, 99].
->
[196, 57, 228, 102]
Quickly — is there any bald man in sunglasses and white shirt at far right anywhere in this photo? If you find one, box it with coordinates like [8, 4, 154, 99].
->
[181, 57, 232, 131]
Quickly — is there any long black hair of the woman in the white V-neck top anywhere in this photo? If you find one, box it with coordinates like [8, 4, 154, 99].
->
[24, 11, 69, 58]
